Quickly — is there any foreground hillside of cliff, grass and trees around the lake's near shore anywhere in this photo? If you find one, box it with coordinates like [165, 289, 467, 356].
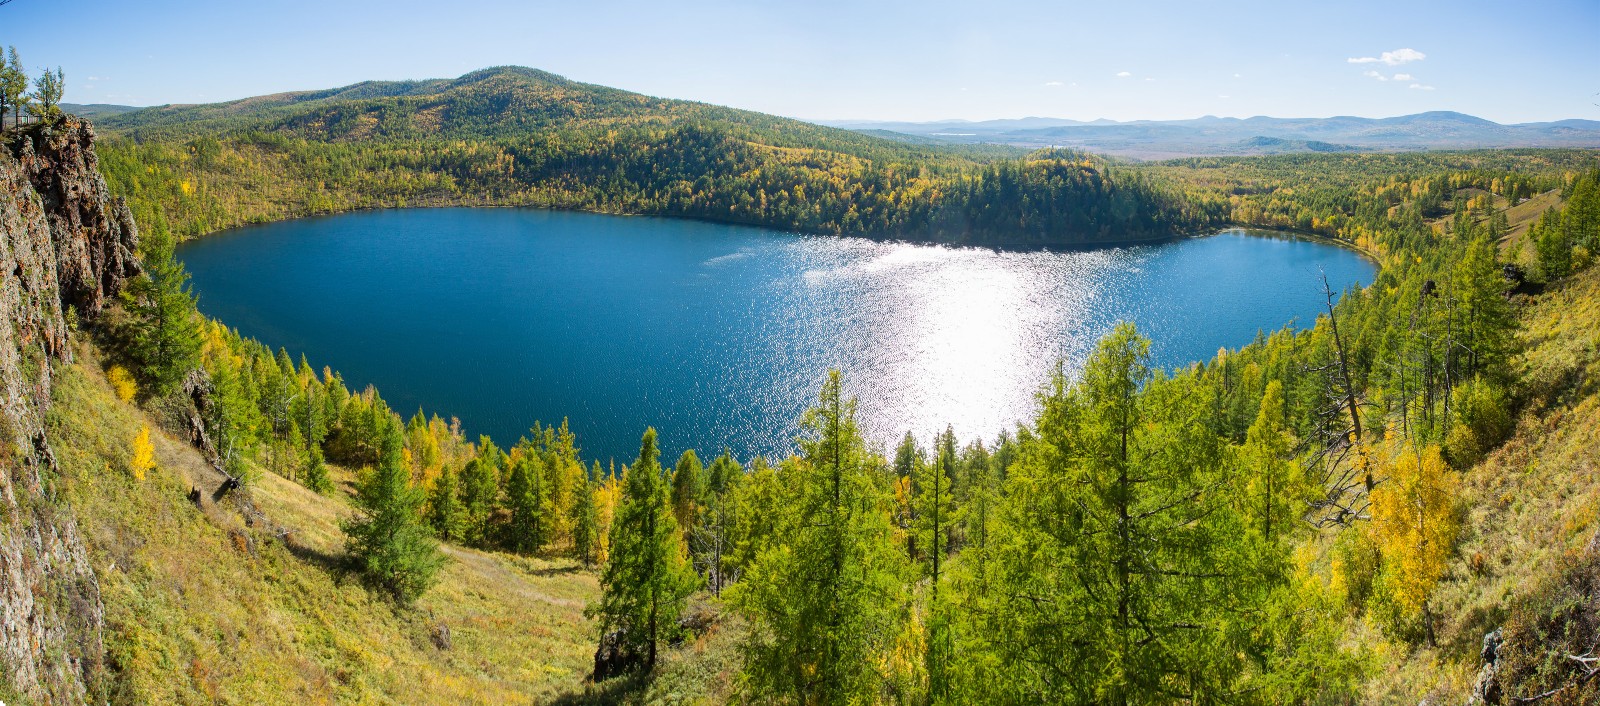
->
[9, 101, 1600, 704]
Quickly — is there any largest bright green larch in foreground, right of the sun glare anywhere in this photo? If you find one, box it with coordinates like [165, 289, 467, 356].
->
[965, 325, 1267, 704]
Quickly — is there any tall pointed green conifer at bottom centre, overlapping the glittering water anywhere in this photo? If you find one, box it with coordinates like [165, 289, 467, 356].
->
[728, 371, 907, 703]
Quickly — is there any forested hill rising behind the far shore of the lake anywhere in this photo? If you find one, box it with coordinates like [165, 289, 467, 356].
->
[90, 67, 1222, 245]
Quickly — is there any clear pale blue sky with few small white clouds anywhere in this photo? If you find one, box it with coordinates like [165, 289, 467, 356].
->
[0, 0, 1600, 122]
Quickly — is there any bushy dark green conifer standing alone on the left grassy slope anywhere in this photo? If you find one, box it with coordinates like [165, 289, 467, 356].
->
[342, 419, 443, 604]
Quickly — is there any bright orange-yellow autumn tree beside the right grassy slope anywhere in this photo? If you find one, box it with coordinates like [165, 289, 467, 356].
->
[1371, 443, 1461, 642]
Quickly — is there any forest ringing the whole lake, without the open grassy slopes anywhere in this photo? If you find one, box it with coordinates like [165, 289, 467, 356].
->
[84, 72, 1600, 704]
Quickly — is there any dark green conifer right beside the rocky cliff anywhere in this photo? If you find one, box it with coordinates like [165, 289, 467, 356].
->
[123, 219, 200, 395]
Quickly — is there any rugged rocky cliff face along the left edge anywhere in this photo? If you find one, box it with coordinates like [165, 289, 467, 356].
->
[0, 118, 138, 703]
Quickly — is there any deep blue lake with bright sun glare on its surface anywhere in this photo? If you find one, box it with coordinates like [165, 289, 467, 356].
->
[178, 208, 1374, 463]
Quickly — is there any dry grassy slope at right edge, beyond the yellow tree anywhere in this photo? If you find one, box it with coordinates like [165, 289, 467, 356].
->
[1366, 267, 1600, 703]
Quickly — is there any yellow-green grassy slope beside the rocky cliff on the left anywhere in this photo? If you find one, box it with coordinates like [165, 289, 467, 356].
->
[50, 339, 736, 704]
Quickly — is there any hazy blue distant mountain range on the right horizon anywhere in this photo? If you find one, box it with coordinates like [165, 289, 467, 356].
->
[827, 110, 1600, 158]
